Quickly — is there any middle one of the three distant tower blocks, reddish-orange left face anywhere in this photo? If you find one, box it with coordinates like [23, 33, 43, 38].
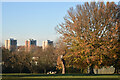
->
[25, 39, 37, 51]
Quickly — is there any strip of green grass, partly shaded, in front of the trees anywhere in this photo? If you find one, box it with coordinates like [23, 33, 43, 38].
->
[1, 73, 120, 80]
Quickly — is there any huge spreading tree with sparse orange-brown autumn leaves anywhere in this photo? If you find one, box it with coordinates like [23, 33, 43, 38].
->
[56, 2, 118, 74]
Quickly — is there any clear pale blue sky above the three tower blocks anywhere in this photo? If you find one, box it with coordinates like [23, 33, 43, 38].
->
[2, 2, 82, 46]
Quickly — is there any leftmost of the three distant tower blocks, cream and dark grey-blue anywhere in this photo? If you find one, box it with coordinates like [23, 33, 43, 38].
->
[5, 38, 17, 51]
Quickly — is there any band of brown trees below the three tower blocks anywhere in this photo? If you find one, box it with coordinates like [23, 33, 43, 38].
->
[2, 46, 57, 73]
